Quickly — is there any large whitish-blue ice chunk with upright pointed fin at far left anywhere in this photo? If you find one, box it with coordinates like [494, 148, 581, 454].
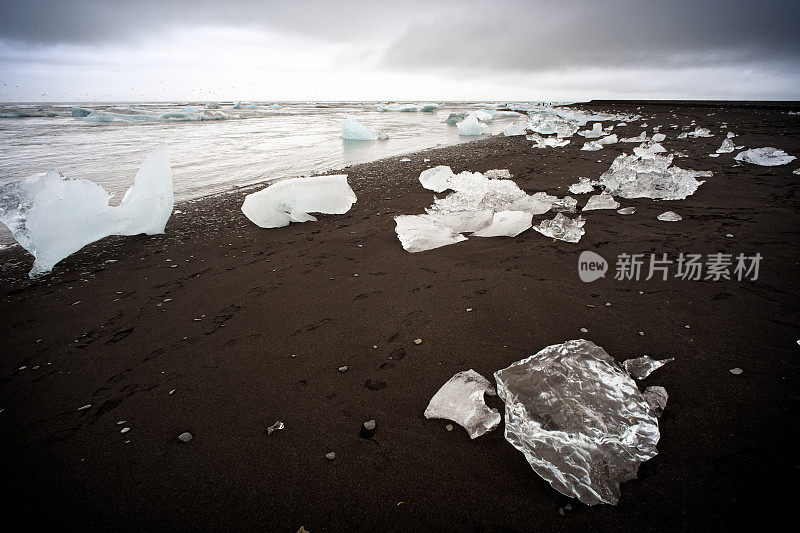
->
[0, 145, 174, 277]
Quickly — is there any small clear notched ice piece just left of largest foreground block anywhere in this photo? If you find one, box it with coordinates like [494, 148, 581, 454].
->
[425, 369, 502, 439]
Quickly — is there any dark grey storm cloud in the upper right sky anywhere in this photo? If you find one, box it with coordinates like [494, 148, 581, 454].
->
[385, 0, 800, 72]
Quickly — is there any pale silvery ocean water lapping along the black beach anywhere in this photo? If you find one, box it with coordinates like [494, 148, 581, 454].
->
[0, 103, 524, 203]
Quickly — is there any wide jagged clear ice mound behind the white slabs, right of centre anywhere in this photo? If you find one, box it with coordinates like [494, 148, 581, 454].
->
[599, 154, 712, 200]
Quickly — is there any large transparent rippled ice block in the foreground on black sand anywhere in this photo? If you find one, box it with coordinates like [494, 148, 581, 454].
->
[494, 339, 660, 505]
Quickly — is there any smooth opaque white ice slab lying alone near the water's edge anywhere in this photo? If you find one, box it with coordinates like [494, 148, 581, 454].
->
[242, 174, 356, 228]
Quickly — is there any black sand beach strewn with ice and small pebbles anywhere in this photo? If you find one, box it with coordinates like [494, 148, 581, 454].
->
[0, 103, 800, 532]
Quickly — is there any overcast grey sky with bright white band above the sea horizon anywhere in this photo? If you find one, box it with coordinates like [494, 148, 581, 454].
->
[0, 0, 800, 101]
